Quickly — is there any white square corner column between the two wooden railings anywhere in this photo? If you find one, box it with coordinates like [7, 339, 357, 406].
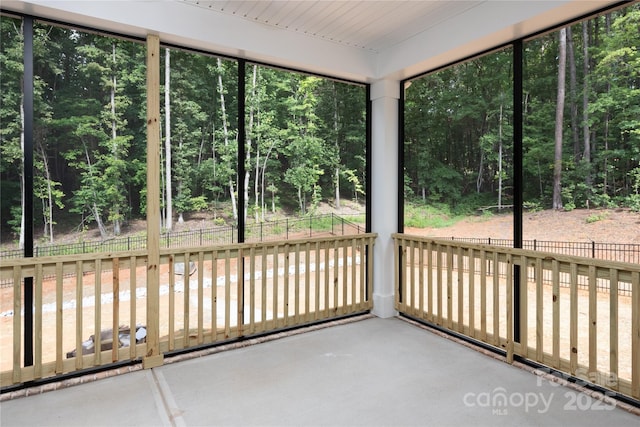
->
[369, 80, 400, 318]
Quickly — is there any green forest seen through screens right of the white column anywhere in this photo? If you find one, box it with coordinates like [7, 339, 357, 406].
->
[404, 3, 640, 213]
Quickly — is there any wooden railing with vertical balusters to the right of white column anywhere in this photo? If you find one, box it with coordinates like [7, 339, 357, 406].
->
[393, 234, 640, 399]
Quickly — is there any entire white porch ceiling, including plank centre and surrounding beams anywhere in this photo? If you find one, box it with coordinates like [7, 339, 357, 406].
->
[0, 0, 620, 82]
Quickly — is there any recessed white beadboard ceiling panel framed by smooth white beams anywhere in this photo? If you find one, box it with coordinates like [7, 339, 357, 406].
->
[182, 0, 486, 53]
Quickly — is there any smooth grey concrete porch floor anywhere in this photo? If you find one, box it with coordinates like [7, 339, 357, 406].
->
[0, 318, 640, 427]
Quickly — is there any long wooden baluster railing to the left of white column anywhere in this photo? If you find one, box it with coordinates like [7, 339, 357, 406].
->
[0, 233, 376, 387]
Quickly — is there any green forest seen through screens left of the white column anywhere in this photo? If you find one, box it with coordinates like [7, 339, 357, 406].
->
[0, 17, 366, 246]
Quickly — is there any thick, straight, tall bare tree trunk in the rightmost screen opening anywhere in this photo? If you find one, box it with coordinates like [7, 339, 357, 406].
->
[553, 28, 567, 209]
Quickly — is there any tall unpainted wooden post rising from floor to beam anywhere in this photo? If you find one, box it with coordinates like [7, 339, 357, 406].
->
[142, 35, 164, 369]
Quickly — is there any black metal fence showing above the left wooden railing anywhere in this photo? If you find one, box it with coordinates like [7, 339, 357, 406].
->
[0, 214, 365, 259]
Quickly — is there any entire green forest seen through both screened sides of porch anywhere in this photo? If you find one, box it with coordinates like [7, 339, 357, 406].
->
[0, 3, 640, 247]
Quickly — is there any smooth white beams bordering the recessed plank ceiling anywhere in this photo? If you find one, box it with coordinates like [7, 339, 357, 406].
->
[1, 0, 618, 82]
